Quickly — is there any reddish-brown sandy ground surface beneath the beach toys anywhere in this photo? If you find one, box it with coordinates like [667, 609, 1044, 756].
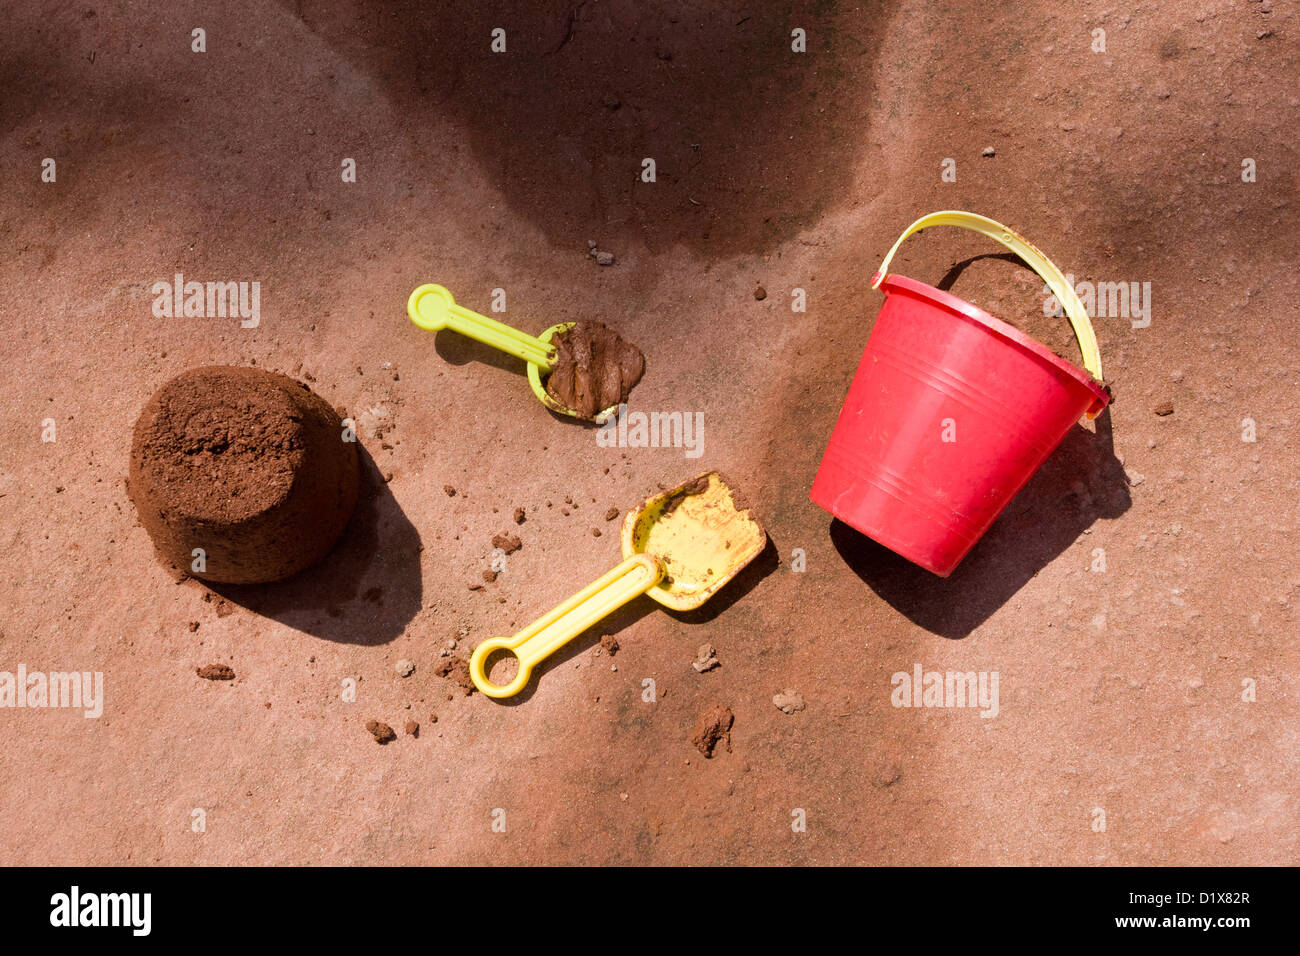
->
[0, 0, 1300, 864]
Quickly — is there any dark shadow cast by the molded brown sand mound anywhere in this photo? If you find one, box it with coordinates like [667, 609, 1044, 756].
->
[207, 442, 423, 645]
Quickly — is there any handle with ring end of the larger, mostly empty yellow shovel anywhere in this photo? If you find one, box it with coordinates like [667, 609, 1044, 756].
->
[469, 554, 664, 697]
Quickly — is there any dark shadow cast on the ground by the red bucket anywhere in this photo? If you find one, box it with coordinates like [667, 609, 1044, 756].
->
[831, 410, 1131, 640]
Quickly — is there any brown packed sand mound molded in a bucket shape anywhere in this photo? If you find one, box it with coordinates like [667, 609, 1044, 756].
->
[127, 365, 359, 584]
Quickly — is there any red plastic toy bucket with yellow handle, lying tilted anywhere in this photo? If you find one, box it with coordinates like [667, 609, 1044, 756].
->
[810, 211, 1110, 578]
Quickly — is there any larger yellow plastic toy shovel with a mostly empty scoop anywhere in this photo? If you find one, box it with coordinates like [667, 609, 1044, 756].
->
[469, 471, 767, 697]
